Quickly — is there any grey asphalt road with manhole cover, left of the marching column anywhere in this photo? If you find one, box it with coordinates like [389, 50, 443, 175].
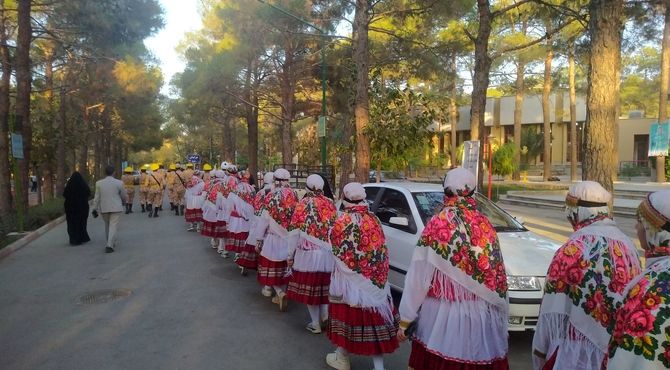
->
[0, 198, 556, 370]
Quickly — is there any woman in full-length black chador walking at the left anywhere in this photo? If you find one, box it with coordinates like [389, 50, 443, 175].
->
[63, 171, 91, 245]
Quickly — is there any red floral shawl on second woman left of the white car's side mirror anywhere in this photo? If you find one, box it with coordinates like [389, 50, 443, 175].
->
[288, 191, 337, 243]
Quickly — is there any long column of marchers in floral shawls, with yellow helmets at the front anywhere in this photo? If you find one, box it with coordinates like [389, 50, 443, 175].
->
[118, 162, 670, 370]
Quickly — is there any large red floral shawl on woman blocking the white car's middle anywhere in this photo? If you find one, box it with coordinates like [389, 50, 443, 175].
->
[417, 196, 507, 298]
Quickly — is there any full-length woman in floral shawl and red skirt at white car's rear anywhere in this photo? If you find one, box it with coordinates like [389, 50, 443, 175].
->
[326, 182, 398, 370]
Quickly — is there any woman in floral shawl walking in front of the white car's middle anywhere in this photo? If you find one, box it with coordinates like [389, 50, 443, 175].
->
[398, 167, 509, 370]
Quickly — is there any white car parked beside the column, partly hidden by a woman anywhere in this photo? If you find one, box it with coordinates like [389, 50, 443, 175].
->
[363, 182, 560, 331]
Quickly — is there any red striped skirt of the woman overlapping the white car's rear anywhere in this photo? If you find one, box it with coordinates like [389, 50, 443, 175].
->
[328, 303, 399, 356]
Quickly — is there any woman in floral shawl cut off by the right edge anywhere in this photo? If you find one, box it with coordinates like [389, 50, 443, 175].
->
[606, 190, 670, 370]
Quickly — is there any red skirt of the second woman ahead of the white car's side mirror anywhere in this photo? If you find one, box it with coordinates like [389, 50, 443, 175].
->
[286, 270, 330, 305]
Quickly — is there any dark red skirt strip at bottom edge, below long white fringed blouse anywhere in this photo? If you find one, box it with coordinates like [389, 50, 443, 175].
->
[409, 340, 509, 370]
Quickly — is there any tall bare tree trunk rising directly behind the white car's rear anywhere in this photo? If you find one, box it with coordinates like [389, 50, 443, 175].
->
[352, 0, 370, 183]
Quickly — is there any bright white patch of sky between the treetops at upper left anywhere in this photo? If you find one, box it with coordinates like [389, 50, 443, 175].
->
[144, 0, 202, 95]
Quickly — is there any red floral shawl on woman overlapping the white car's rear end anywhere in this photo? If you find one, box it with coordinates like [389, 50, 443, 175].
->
[330, 205, 389, 289]
